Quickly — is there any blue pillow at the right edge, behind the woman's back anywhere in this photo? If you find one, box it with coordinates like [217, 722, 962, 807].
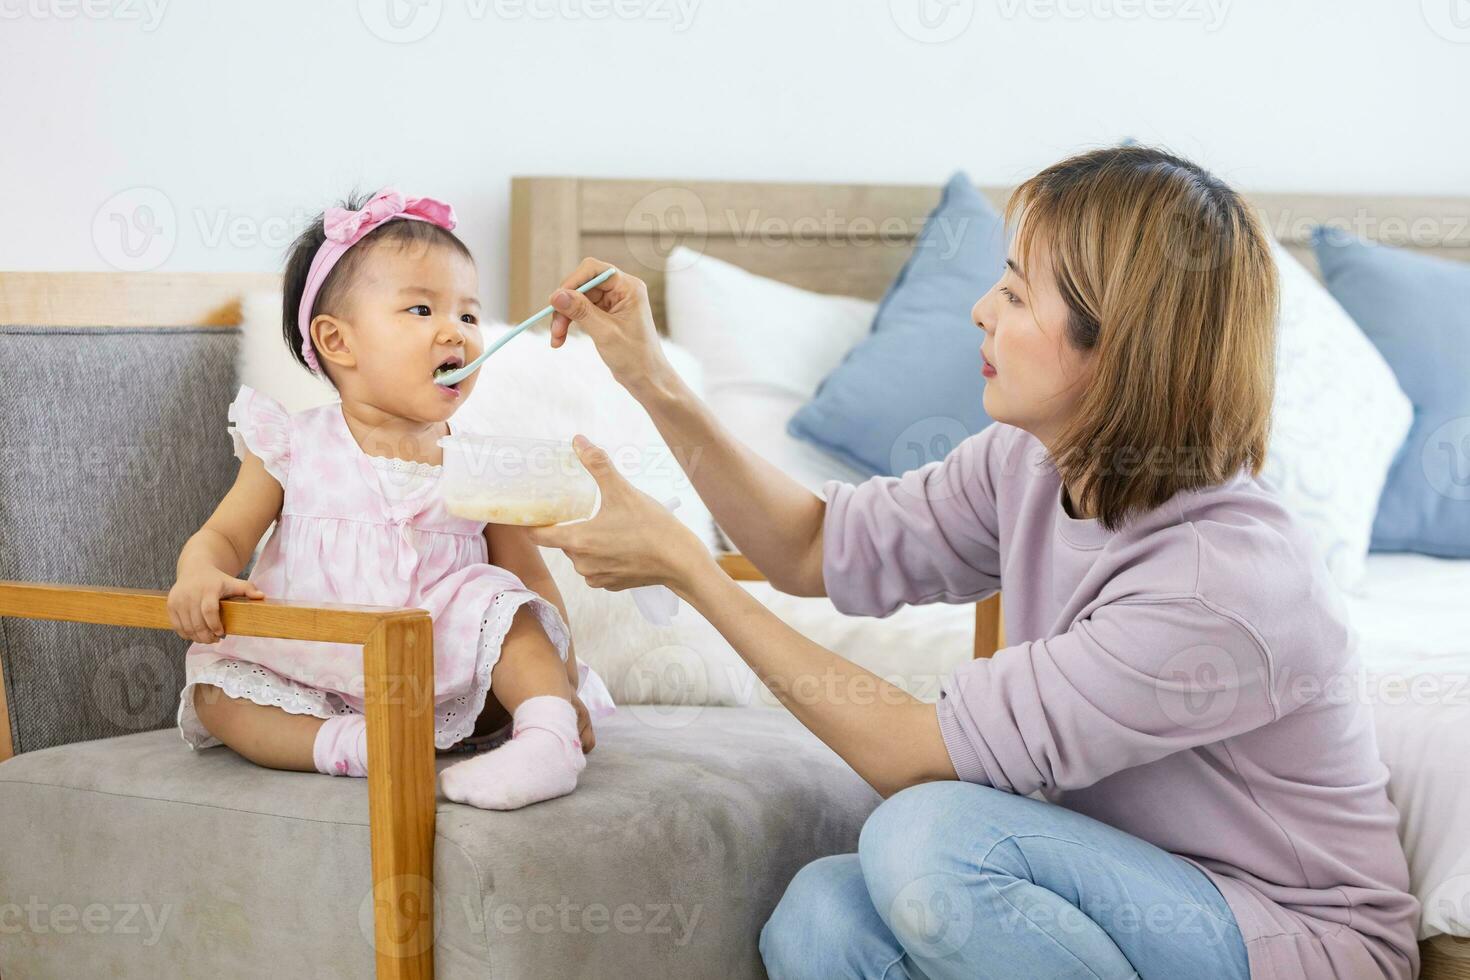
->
[1311, 228, 1470, 558]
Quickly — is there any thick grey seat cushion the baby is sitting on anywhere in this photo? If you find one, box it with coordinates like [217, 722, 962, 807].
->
[0, 707, 879, 980]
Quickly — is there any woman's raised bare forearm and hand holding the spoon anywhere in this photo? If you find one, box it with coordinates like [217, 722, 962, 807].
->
[551, 259, 826, 595]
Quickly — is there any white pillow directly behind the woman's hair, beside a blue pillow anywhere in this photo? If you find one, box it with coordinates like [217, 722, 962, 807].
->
[1261, 241, 1413, 591]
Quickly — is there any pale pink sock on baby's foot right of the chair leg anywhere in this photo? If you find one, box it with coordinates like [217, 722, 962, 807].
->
[440, 695, 587, 810]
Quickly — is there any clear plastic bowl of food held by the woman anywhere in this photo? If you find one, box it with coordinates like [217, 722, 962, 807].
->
[438, 433, 597, 527]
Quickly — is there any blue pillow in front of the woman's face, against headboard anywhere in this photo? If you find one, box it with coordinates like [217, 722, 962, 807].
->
[786, 172, 1005, 475]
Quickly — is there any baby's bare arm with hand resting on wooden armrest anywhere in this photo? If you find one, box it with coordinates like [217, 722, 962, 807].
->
[169, 450, 285, 644]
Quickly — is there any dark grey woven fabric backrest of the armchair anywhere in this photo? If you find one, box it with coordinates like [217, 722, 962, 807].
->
[0, 326, 240, 752]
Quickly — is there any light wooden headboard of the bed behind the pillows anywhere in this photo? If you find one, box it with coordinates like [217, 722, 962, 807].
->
[509, 176, 1470, 329]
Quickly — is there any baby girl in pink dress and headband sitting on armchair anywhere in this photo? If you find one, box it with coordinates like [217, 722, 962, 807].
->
[169, 188, 613, 810]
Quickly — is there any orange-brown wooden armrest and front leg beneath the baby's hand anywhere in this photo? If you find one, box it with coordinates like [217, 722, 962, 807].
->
[0, 580, 435, 980]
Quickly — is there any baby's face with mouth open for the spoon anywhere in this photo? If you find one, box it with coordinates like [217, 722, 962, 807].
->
[345, 242, 484, 422]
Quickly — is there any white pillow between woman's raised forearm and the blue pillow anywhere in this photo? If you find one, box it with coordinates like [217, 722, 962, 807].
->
[664, 247, 878, 492]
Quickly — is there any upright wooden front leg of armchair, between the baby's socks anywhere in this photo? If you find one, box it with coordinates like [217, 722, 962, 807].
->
[363, 614, 435, 980]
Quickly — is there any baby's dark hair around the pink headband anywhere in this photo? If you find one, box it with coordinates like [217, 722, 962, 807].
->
[281, 191, 475, 372]
